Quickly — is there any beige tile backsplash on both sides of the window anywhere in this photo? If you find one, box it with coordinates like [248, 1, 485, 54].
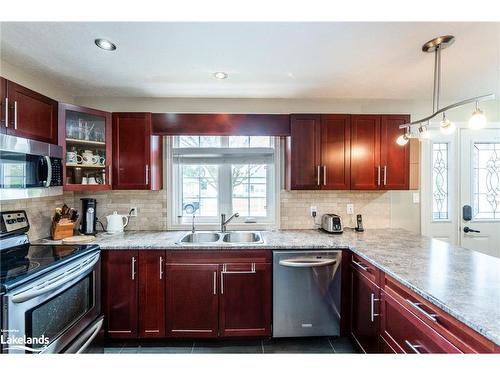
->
[0, 190, 420, 239]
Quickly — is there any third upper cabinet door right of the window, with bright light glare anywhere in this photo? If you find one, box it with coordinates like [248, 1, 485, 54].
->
[351, 115, 382, 190]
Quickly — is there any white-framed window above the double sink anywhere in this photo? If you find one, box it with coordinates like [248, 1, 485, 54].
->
[166, 136, 280, 229]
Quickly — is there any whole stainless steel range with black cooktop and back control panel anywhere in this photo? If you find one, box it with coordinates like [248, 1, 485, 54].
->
[0, 211, 103, 353]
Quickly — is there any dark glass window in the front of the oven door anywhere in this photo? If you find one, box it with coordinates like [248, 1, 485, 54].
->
[26, 275, 93, 348]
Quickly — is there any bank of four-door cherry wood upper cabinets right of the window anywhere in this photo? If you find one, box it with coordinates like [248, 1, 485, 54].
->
[287, 114, 410, 190]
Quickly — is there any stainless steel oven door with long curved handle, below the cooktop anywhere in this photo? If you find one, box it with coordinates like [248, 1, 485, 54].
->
[3, 252, 101, 353]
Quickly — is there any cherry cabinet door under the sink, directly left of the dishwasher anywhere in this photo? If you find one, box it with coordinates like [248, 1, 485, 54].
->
[220, 263, 271, 337]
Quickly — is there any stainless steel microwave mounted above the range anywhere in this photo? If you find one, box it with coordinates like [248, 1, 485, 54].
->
[0, 134, 63, 200]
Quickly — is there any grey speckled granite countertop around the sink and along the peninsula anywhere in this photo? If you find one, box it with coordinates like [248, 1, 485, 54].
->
[35, 229, 500, 345]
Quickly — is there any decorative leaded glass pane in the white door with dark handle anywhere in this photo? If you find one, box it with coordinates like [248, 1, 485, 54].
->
[472, 143, 500, 220]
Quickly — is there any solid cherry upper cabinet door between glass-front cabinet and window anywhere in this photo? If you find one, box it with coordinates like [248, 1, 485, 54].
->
[113, 113, 151, 190]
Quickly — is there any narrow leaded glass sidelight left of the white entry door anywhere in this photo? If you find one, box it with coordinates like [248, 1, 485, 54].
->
[432, 143, 449, 220]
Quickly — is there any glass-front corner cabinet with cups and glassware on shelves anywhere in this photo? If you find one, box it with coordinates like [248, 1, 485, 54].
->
[59, 104, 112, 191]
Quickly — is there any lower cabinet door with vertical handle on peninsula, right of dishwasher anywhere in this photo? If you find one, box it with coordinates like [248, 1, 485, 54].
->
[351, 269, 380, 353]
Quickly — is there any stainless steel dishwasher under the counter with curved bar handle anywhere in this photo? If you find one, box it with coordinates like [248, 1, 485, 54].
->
[273, 250, 342, 337]
